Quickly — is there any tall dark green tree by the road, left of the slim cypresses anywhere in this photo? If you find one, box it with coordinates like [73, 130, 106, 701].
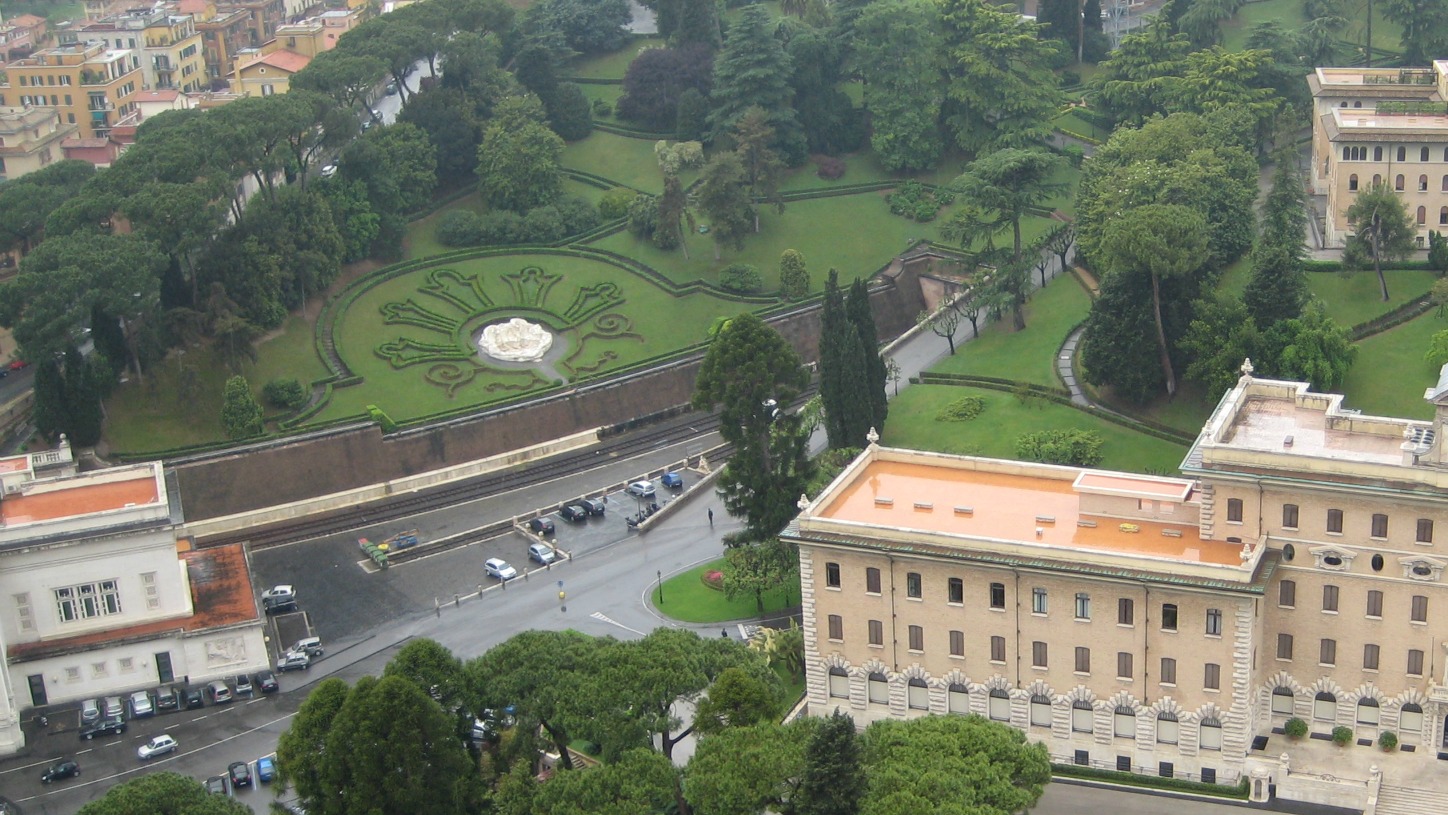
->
[694, 314, 812, 540]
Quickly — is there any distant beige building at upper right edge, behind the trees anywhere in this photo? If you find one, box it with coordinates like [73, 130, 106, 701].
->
[1308, 59, 1448, 246]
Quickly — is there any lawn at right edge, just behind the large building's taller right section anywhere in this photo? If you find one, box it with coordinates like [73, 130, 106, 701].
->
[1341, 311, 1448, 418]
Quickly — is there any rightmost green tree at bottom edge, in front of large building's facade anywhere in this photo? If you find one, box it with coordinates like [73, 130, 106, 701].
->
[860, 717, 1051, 815]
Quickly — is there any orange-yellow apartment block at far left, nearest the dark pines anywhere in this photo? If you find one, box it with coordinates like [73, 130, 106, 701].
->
[0, 42, 143, 139]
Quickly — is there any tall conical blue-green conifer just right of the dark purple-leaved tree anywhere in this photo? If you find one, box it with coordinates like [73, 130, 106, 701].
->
[708, 6, 807, 165]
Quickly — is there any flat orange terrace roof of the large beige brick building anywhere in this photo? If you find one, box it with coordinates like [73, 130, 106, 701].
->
[811, 459, 1241, 566]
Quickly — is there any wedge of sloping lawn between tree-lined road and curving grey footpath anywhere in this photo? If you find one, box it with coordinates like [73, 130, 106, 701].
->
[931, 275, 1090, 388]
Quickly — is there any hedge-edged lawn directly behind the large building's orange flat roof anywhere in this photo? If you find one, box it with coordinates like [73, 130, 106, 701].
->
[882, 385, 1186, 473]
